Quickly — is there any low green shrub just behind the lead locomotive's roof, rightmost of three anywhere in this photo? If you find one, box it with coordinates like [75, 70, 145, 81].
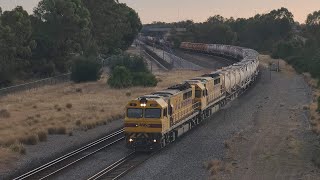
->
[133, 72, 158, 87]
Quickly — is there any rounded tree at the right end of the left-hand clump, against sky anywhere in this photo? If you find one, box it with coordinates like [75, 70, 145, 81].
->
[84, 0, 142, 55]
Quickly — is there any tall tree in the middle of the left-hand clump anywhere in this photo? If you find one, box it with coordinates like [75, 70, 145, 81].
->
[33, 0, 95, 72]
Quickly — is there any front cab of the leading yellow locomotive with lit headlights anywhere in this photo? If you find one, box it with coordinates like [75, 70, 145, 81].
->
[124, 95, 169, 151]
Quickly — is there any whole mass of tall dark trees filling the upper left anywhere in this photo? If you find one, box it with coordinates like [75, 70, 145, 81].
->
[0, 0, 142, 86]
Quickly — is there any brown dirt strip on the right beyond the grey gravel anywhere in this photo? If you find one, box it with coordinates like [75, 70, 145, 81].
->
[209, 56, 320, 180]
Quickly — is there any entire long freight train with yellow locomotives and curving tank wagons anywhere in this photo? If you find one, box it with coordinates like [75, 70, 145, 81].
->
[124, 42, 259, 151]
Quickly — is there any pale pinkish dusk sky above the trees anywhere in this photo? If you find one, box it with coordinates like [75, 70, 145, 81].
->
[0, 0, 320, 24]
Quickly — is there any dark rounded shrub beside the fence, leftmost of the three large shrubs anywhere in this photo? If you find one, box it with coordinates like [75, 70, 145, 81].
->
[71, 56, 101, 83]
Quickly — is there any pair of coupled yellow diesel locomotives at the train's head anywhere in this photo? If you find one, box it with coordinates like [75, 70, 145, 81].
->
[124, 75, 224, 151]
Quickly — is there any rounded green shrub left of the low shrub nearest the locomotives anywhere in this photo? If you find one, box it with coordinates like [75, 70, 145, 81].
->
[108, 66, 132, 88]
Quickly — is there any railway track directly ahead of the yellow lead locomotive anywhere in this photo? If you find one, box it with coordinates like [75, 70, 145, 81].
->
[88, 152, 156, 180]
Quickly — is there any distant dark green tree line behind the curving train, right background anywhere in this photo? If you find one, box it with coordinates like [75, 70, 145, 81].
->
[142, 8, 320, 85]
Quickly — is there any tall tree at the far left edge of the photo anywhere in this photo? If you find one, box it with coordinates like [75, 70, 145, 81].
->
[0, 6, 36, 85]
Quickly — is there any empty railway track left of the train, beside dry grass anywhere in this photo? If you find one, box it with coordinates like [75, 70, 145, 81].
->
[14, 129, 124, 180]
